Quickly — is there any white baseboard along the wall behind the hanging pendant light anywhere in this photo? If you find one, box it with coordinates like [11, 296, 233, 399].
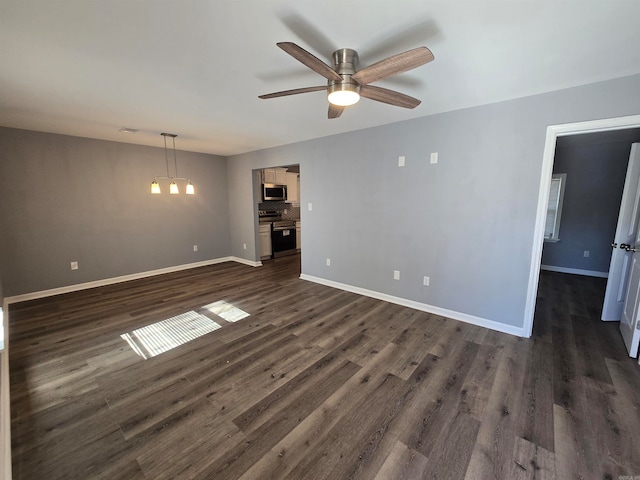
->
[4, 256, 262, 306]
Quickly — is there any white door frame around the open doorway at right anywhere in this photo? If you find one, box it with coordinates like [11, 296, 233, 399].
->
[522, 115, 640, 338]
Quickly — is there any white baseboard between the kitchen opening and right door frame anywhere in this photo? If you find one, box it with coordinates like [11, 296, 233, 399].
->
[300, 273, 525, 337]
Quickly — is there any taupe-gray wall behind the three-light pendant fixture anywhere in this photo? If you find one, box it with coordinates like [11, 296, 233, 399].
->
[0, 128, 231, 296]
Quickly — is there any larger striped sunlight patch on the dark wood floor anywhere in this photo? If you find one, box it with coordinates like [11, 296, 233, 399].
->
[120, 311, 224, 360]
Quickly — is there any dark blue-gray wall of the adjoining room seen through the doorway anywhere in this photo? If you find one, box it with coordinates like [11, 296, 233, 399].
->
[542, 142, 631, 272]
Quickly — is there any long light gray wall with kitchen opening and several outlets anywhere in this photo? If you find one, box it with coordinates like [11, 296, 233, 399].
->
[228, 75, 640, 327]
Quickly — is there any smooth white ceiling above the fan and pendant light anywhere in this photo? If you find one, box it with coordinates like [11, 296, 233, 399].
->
[0, 0, 640, 155]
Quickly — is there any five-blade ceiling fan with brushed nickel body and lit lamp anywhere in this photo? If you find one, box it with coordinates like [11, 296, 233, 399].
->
[258, 42, 434, 118]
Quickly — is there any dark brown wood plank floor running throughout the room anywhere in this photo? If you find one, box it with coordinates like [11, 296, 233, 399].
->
[9, 257, 640, 480]
